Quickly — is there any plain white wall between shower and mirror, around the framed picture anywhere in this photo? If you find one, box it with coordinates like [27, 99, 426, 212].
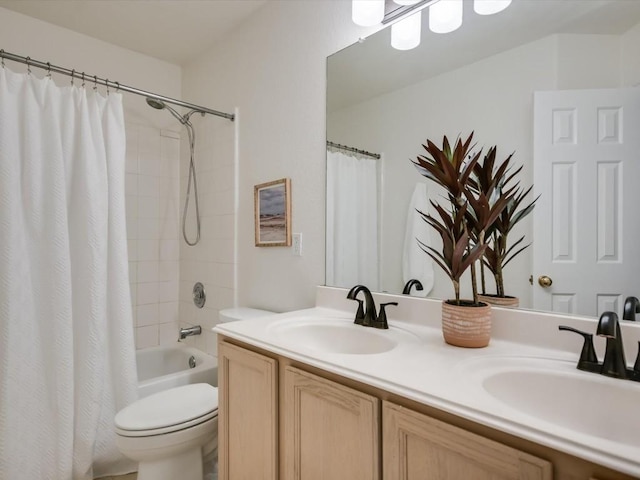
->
[183, 0, 366, 311]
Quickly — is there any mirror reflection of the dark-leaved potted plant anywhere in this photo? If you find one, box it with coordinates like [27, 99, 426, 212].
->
[471, 146, 537, 307]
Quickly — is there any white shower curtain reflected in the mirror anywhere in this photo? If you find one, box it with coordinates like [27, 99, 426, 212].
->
[326, 149, 380, 290]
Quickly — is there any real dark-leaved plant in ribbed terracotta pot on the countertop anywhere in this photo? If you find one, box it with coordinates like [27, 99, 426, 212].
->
[413, 133, 512, 347]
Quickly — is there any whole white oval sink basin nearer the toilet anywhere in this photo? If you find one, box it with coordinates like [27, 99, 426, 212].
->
[271, 318, 418, 355]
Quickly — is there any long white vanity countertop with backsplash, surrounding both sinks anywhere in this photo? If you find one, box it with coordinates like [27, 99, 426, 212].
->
[214, 287, 640, 477]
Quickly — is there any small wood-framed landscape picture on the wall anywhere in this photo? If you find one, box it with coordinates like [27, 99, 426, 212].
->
[253, 178, 291, 247]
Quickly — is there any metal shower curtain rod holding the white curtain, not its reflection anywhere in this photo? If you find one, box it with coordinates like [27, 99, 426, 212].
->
[0, 50, 235, 122]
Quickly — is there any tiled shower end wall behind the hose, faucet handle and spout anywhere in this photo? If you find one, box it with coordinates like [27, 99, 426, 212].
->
[179, 115, 237, 355]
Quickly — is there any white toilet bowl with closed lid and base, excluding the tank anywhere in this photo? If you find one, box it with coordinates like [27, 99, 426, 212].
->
[115, 383, 218, 480]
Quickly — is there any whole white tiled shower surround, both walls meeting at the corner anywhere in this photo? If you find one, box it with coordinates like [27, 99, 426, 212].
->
[126, 115, 236, 355]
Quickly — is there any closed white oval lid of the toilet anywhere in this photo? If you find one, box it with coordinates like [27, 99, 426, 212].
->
[115, 383, 218, 432]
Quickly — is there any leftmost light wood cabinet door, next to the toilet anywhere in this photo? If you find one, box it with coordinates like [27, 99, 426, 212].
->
[218, 342, 278, 480]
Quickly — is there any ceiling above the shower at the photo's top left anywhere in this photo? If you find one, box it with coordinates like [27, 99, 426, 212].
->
[0, 0, 267, 65]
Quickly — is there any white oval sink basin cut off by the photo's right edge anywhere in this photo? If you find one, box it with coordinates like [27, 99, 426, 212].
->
[480, 358, 640, 446]
